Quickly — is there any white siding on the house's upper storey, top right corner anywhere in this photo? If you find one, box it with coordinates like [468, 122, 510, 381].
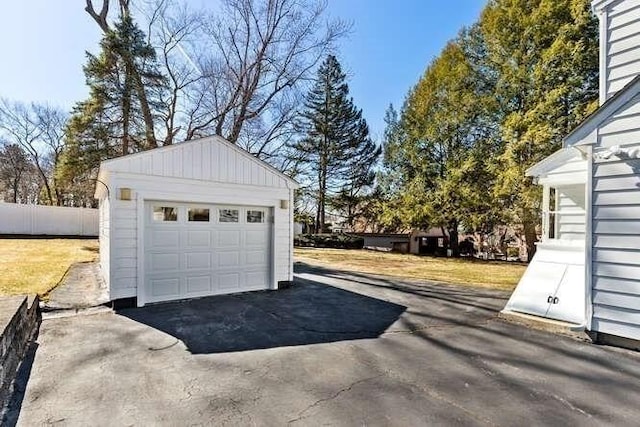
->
[600, 0, 640, 102]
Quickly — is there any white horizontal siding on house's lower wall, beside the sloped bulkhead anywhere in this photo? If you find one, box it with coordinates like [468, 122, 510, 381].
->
[592, 93, 640, 339]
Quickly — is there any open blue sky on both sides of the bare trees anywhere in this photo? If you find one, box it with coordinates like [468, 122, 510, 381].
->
[0, 0, 486, 139]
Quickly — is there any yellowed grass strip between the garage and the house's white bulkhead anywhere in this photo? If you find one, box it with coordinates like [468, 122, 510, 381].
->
[294, 248, 526, 290]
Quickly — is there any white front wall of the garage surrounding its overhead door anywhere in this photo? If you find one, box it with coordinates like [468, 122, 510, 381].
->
[110, 172, 293, 299]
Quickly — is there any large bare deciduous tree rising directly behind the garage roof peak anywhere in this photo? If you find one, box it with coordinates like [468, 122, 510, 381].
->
[203, 0, 348, 156]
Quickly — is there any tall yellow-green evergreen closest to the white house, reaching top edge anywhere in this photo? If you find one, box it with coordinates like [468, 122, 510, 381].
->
[481, 0, 598, 258]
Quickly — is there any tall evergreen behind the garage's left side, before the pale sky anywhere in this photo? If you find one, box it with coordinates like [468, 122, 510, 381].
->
[56, 13, 164, 204]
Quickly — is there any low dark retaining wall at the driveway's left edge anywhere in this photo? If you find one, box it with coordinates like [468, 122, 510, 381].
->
[0, 295, 41, 409]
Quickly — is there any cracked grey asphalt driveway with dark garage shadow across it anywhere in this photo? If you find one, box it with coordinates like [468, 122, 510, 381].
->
[10, 265, 640, 426]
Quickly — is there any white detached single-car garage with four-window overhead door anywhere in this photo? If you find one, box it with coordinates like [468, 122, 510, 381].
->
[95, 137, 298, 306]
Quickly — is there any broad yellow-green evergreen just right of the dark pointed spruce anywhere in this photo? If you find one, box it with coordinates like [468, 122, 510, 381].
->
[383, 34, 500, 253]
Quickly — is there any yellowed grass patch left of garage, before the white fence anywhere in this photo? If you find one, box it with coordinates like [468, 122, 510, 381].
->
[0, 239, 98, 295]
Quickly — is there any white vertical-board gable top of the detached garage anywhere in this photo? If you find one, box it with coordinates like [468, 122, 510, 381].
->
[100, 136, 299, 188]
